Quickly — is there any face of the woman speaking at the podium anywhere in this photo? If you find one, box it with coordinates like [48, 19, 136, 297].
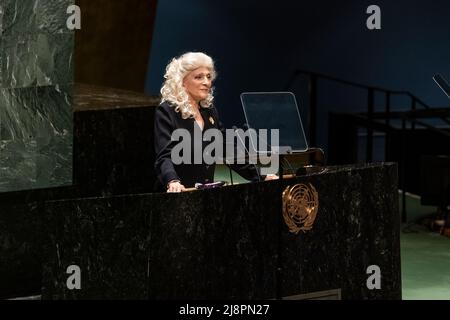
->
[183, 67, 212, 103]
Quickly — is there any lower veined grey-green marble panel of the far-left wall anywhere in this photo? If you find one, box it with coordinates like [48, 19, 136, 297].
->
[0, 85, 73, 192]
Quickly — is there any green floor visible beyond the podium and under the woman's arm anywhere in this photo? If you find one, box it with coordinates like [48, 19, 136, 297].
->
[215, 167, 450, 300]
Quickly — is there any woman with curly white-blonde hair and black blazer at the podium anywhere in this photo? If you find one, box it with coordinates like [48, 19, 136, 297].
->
[154, 52, 274, 192]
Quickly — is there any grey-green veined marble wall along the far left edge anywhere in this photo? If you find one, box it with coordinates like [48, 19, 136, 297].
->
[0, 0, 75, 192]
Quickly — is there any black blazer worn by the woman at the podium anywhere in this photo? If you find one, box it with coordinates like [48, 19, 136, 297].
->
[154, 102, 261, 191]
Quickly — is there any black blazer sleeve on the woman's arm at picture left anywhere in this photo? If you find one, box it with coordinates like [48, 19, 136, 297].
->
[154, 106, 179, 187]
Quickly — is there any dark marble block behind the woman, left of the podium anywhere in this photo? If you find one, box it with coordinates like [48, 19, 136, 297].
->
[0, 84, 159, 299]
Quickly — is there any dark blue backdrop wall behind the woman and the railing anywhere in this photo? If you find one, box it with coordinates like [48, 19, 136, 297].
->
[145, 0, 450, 155]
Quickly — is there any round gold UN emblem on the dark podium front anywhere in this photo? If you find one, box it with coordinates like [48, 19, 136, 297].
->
[283, 184, 319, 234]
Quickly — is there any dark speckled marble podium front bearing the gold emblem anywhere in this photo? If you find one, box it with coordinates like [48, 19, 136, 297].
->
[42, 163, 401, 299]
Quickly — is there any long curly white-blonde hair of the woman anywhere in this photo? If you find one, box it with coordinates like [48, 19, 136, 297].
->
[161, 52, 216, 119]
